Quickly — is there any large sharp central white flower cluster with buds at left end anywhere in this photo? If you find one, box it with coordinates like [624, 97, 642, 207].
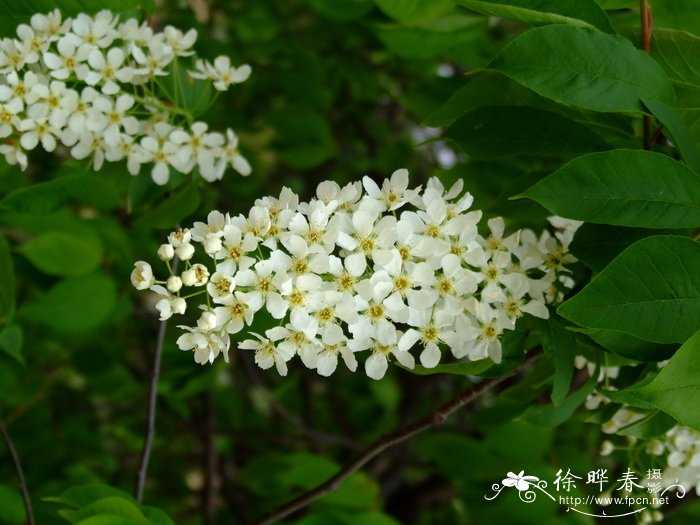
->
[131, 169, 575, 379]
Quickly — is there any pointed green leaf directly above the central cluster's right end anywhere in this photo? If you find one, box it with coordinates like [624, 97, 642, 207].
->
[522, 150, 700, 229]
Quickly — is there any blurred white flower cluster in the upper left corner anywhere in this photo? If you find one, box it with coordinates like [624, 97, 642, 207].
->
[0, 10, 250, 184]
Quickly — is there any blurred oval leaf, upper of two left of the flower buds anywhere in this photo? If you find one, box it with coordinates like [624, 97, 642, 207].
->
[19, 231, 102, 276]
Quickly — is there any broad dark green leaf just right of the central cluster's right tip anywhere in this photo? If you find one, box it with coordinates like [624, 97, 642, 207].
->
[558, 236, 700, 343]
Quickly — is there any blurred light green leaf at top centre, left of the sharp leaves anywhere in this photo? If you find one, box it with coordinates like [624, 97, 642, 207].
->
[374, 14, 486, 60]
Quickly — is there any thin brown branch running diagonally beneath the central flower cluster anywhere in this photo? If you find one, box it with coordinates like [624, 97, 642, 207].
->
[255, 351, 541, 525]
